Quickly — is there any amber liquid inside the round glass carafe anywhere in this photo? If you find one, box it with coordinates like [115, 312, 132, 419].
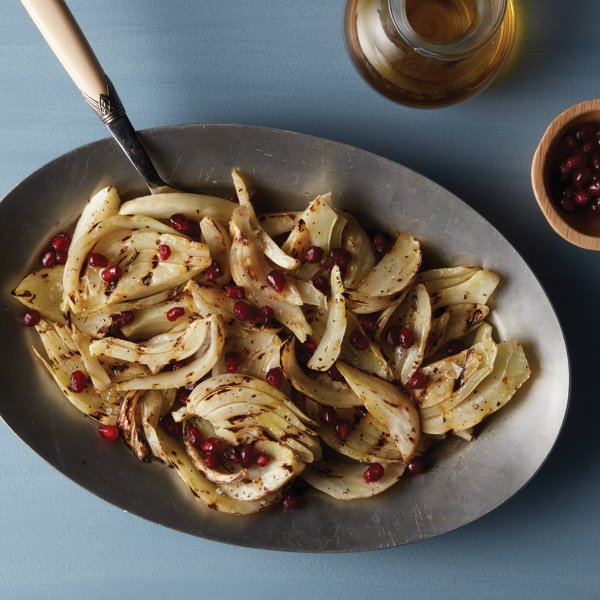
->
[345, 0, 516, 108]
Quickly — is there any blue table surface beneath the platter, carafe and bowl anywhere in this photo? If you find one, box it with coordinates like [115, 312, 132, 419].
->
[0, 0, 600, 599]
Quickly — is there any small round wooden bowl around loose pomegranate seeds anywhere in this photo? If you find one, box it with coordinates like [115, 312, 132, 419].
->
[531, 99, 600, 250]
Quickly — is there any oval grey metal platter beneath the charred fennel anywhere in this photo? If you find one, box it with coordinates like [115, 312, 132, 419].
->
[0, 124, 569, 552]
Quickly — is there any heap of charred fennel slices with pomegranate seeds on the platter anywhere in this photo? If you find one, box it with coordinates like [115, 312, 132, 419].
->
[13, 171, 529, 515]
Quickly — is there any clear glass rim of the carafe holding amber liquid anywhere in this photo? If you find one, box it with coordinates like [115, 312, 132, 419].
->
[388, 0, 509, 60]
